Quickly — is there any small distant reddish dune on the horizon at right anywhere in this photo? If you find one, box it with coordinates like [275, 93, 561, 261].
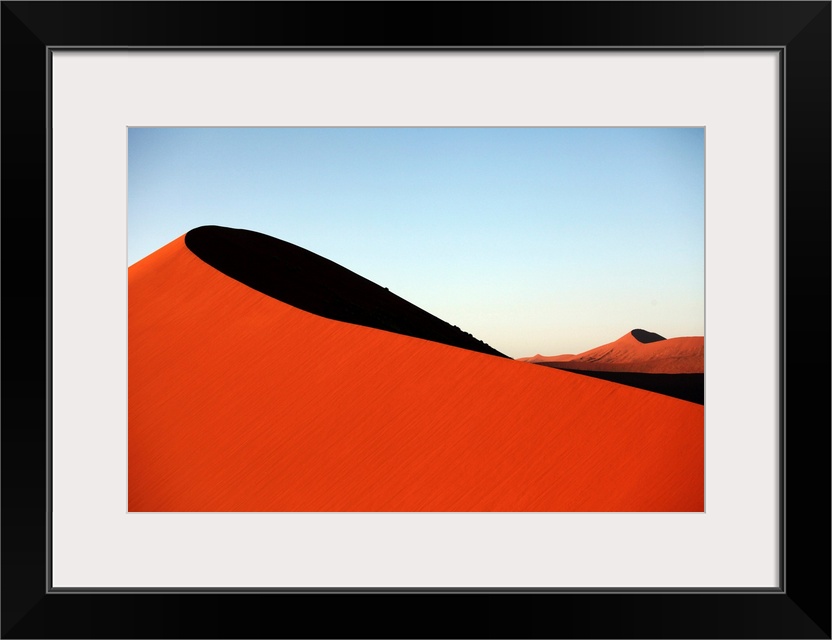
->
[518, 329, 705, 373]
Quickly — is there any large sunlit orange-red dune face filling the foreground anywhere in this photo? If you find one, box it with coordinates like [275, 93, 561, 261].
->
[128, 238, 704, 511]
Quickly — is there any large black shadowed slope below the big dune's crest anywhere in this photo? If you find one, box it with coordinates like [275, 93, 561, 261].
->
[185, 226, 507, 358]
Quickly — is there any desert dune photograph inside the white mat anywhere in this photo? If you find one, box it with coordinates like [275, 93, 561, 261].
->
[127, 127, 706, 513]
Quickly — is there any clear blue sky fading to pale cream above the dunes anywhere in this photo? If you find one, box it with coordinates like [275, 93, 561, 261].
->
[128, 128, 705, 357]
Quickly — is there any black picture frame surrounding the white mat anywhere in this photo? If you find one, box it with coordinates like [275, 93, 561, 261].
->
[0, 1, 832, 638]
